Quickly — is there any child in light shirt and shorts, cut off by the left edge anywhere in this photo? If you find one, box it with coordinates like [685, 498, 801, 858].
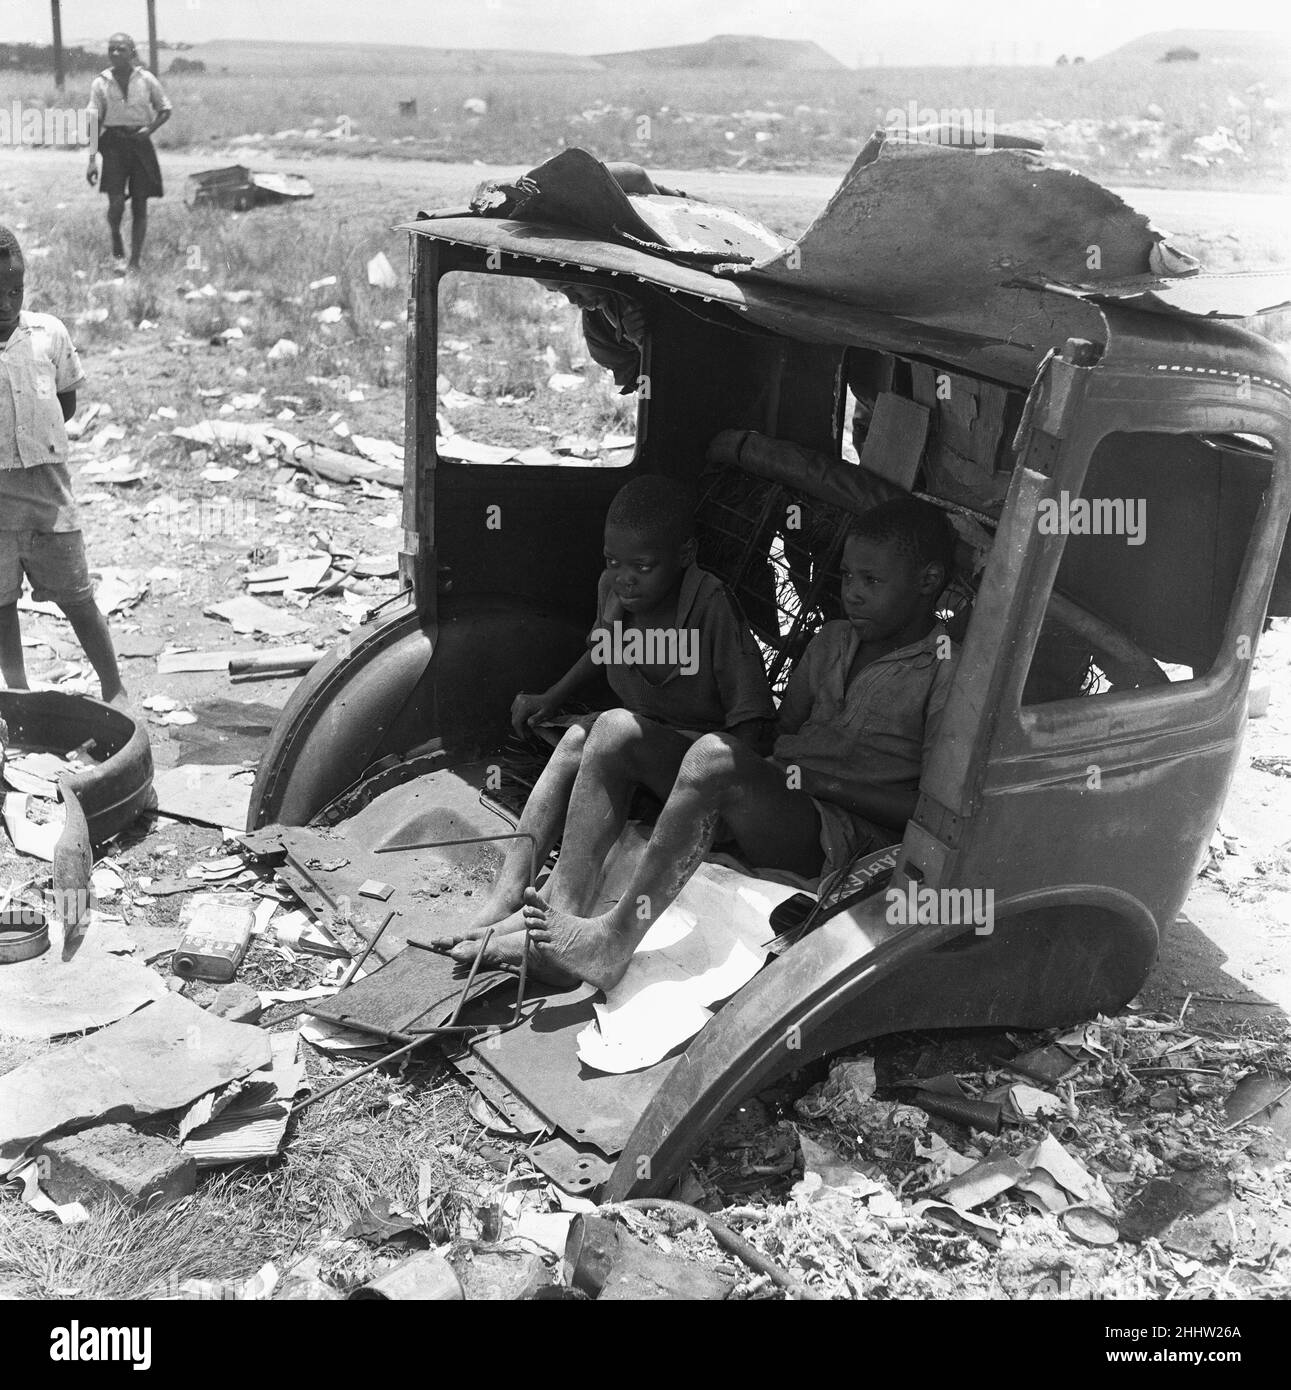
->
[0, 227, 125, 705]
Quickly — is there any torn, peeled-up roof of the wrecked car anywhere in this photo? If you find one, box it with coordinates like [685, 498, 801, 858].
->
[404, 140, 1291, 385]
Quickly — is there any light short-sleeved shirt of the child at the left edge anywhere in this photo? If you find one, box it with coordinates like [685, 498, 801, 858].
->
[0, 309, 85, 468]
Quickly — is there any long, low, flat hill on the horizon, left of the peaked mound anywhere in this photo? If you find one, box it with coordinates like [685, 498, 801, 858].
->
[177, 39, 600, 78]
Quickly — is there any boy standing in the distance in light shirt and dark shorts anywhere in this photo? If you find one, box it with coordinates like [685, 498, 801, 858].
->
[85, 33, 172, 270]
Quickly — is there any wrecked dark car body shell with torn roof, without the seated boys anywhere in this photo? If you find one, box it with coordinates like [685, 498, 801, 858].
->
[241, 136, 1291, 1197]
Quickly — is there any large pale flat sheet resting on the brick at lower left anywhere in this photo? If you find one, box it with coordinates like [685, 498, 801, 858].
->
[0, 994, 271, 1158]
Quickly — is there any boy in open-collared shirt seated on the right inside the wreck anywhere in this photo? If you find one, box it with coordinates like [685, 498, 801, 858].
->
[453, 498, 956, 990]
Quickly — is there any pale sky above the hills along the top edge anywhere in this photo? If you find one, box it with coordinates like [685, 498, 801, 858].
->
[10, 0, 1291, 65]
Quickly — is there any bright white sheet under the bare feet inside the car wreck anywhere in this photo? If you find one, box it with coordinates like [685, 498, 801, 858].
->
[578, 826, 795, 1073]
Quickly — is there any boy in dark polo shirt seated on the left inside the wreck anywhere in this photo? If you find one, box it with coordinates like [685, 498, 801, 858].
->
[434, 474, 775, 959]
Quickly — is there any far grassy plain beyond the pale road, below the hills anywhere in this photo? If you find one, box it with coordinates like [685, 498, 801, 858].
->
[0, 44, 1288, 182]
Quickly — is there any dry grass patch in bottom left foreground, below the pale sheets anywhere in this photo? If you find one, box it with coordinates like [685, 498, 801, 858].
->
[0, 1052, 511, 1300]
